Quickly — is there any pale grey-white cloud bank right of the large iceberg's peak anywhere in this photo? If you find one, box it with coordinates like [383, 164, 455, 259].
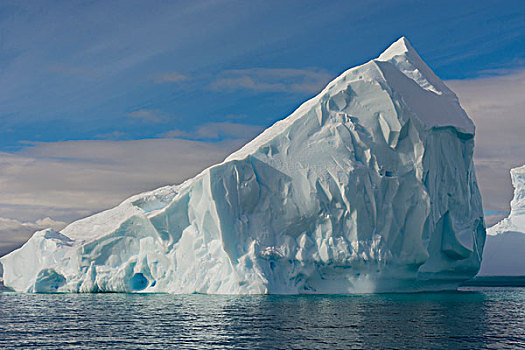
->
[446, 70, 525, 213]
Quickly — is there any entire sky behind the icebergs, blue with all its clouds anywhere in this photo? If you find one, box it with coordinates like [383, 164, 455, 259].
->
[0, 0, 525, 255]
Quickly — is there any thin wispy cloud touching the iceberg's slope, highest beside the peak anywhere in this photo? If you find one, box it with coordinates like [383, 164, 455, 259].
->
[208, 68, 332, 93]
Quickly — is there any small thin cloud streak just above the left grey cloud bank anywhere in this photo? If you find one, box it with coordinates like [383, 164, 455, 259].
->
[161, 122, 263, 140]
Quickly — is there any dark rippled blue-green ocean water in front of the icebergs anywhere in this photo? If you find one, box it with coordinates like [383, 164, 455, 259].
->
[0, 287, 525, 350]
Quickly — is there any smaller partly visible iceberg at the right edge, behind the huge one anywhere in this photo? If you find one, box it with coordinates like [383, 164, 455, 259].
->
[479, 165, 525, 276]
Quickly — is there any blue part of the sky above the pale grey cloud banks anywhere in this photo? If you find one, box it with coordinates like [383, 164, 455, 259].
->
[0, 1, 525, 151]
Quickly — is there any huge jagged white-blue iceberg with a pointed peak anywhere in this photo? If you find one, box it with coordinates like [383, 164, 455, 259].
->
[1, 38, 485, 294]
